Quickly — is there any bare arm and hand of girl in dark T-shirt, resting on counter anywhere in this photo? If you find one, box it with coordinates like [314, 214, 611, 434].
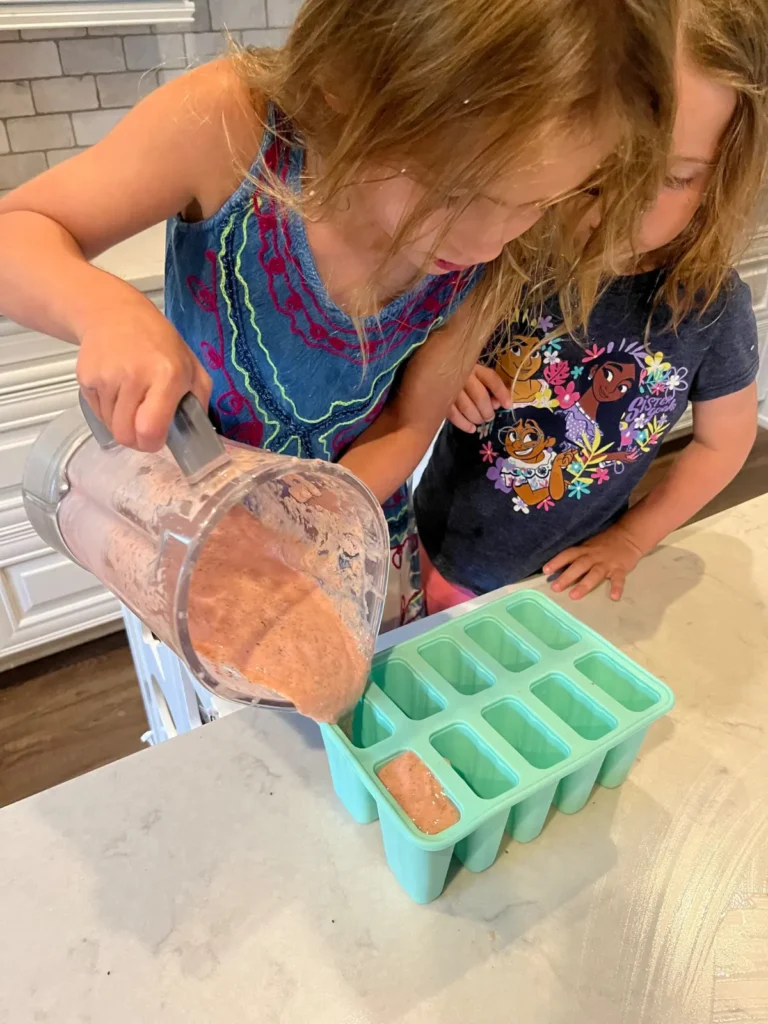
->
[544, 384, 758, 601]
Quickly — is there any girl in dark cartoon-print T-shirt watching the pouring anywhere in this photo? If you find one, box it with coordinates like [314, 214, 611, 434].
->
[416, 0, 768, 612]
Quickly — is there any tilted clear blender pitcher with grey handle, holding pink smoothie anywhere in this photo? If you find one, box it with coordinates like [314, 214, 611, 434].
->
[23, 394, 389, 721]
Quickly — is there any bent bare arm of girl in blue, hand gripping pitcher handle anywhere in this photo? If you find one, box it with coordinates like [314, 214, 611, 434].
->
[0, 61, 260, 451]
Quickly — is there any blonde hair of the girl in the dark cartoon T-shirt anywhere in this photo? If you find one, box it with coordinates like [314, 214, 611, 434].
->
[658, 0, 768, 326]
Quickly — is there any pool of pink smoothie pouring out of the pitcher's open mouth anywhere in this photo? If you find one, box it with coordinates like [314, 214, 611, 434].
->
[188, 505, 369, 722]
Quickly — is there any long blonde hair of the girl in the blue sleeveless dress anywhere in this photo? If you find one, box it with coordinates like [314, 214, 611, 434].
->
[233, 0, 675, 346]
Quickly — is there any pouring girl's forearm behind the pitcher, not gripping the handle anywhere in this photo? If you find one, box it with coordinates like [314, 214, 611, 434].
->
[340, 298, 501, 502]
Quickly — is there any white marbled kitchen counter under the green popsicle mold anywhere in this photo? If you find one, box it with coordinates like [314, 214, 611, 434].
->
[0, 496, 768, 1024]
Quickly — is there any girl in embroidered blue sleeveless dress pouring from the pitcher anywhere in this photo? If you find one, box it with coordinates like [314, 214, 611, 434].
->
[0, 0, 674, 623]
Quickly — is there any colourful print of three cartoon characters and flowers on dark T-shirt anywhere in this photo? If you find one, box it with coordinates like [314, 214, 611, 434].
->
[479, 305, 688, 515]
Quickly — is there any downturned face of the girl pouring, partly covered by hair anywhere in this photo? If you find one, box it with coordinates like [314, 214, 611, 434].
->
[369, 123, 613, 273]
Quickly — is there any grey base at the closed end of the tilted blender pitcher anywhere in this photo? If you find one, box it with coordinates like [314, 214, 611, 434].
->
[22, 406, 91, 557]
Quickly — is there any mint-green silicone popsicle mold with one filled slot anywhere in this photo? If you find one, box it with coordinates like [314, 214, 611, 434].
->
[321, 591, 675, 903]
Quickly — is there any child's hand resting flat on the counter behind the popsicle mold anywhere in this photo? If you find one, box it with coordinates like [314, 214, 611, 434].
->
[544, 524, 644, 601]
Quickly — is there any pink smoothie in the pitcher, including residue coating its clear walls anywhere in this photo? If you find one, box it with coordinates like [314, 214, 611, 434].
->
[60, 445, 378, 722]
